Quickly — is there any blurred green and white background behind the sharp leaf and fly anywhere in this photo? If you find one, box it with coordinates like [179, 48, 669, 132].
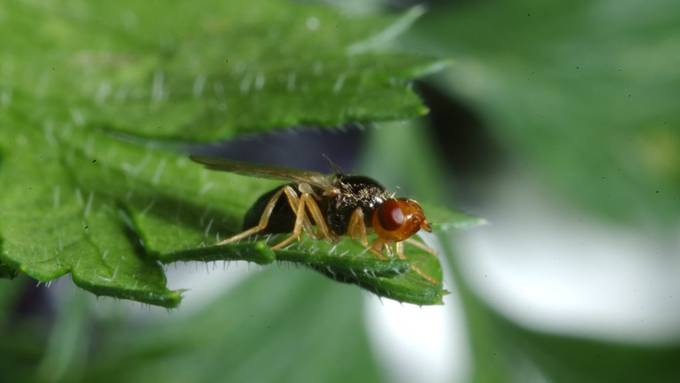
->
[0, 0, 680, 382]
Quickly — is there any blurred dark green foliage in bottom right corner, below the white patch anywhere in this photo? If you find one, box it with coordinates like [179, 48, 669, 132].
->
[444, 237, 680, 383]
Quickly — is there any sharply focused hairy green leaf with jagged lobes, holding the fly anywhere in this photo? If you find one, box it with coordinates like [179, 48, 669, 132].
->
[0, 0, 468, 307]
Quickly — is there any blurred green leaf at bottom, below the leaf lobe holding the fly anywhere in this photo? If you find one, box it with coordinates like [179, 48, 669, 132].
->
[37, 270, 381, 382]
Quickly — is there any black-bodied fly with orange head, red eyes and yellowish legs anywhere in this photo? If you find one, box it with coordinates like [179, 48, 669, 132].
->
[191, 156, 437, 284]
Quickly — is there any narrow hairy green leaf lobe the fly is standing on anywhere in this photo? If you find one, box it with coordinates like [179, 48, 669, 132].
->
[64, 132, 475, 304]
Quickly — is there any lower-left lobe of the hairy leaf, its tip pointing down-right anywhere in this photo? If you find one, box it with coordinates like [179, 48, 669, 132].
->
[0, 124, 180, 306]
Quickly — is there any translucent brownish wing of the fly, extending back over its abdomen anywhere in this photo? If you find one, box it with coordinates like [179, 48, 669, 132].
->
[190, 155, 334, 190]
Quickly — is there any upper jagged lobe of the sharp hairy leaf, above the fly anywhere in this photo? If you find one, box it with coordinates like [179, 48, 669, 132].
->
[0, 0, 441, 140]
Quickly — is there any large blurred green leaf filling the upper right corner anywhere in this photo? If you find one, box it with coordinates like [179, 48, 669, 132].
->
[408, 0, 680, 227]
